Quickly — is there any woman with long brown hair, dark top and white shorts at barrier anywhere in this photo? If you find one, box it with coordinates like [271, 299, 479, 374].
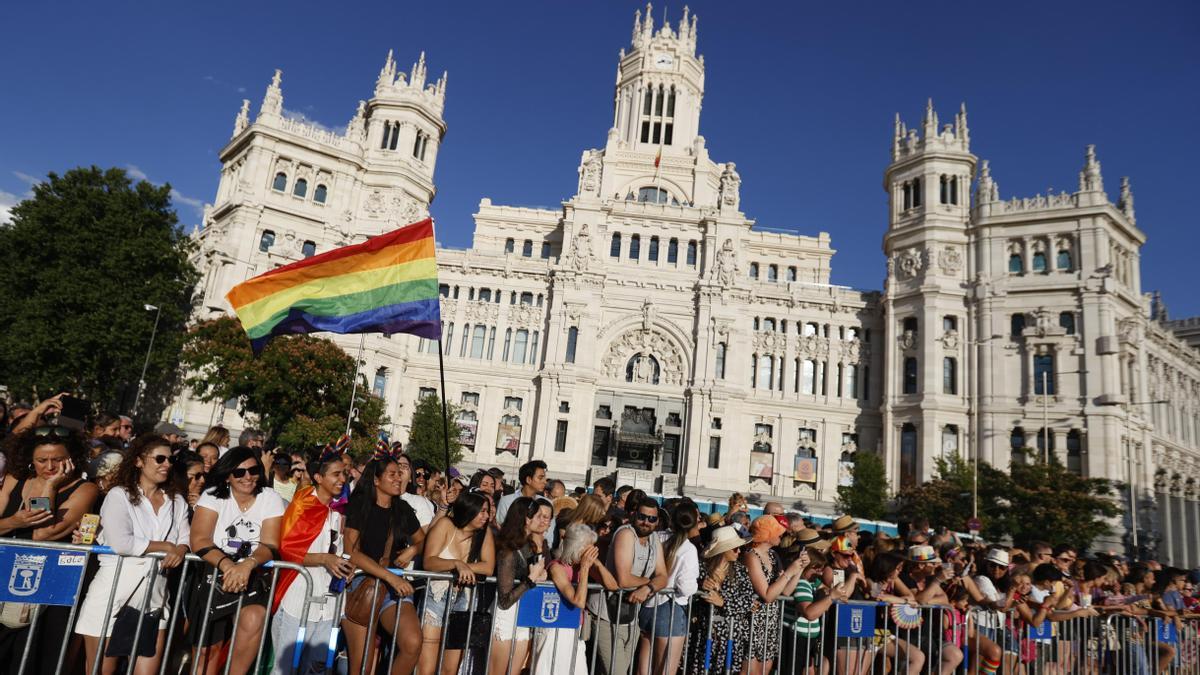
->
[487, 497, 552, 675]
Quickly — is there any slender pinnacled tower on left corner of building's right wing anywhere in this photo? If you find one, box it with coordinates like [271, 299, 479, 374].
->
[883, 101, 976, 488]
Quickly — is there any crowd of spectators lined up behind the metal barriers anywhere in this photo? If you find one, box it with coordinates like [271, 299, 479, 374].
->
[0, 391, 1200, 675]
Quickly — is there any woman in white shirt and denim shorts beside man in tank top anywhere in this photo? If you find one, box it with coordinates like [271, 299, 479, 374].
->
[637, 498, 707, 675]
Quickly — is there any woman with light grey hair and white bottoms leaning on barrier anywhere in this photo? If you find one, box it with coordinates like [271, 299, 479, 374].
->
[532, 522, 618, 675]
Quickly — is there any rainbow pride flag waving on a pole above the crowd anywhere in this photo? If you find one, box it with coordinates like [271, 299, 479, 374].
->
[226, 219, 442, 354]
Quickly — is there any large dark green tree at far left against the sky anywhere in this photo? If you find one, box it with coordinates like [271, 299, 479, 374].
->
[0, 167, 198, 420]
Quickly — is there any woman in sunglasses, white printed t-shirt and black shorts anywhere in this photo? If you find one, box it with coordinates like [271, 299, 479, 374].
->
[188, 447, 284, 675]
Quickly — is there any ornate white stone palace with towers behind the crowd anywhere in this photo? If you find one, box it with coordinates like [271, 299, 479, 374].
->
[172, 6, 1200, 565]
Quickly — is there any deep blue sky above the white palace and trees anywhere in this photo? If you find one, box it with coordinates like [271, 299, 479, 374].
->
[0, 0, 1200, 317]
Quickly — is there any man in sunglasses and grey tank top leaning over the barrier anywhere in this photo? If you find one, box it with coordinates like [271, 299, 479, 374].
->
[588, 498, 667, 675]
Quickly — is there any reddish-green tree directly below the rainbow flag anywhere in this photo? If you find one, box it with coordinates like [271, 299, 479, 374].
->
[181, 317, 388, 455]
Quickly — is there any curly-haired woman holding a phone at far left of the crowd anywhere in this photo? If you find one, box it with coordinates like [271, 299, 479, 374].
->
[0, 425, 97, 673]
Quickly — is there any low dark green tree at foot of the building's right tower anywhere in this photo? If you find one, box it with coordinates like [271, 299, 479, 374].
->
[896, 455, 1012, 542]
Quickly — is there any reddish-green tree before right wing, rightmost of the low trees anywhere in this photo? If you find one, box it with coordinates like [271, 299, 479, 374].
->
[1009, 449, 1122, 550]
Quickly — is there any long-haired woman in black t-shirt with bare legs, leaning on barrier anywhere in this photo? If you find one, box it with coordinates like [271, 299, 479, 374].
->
[342, 450, 425, 675]
